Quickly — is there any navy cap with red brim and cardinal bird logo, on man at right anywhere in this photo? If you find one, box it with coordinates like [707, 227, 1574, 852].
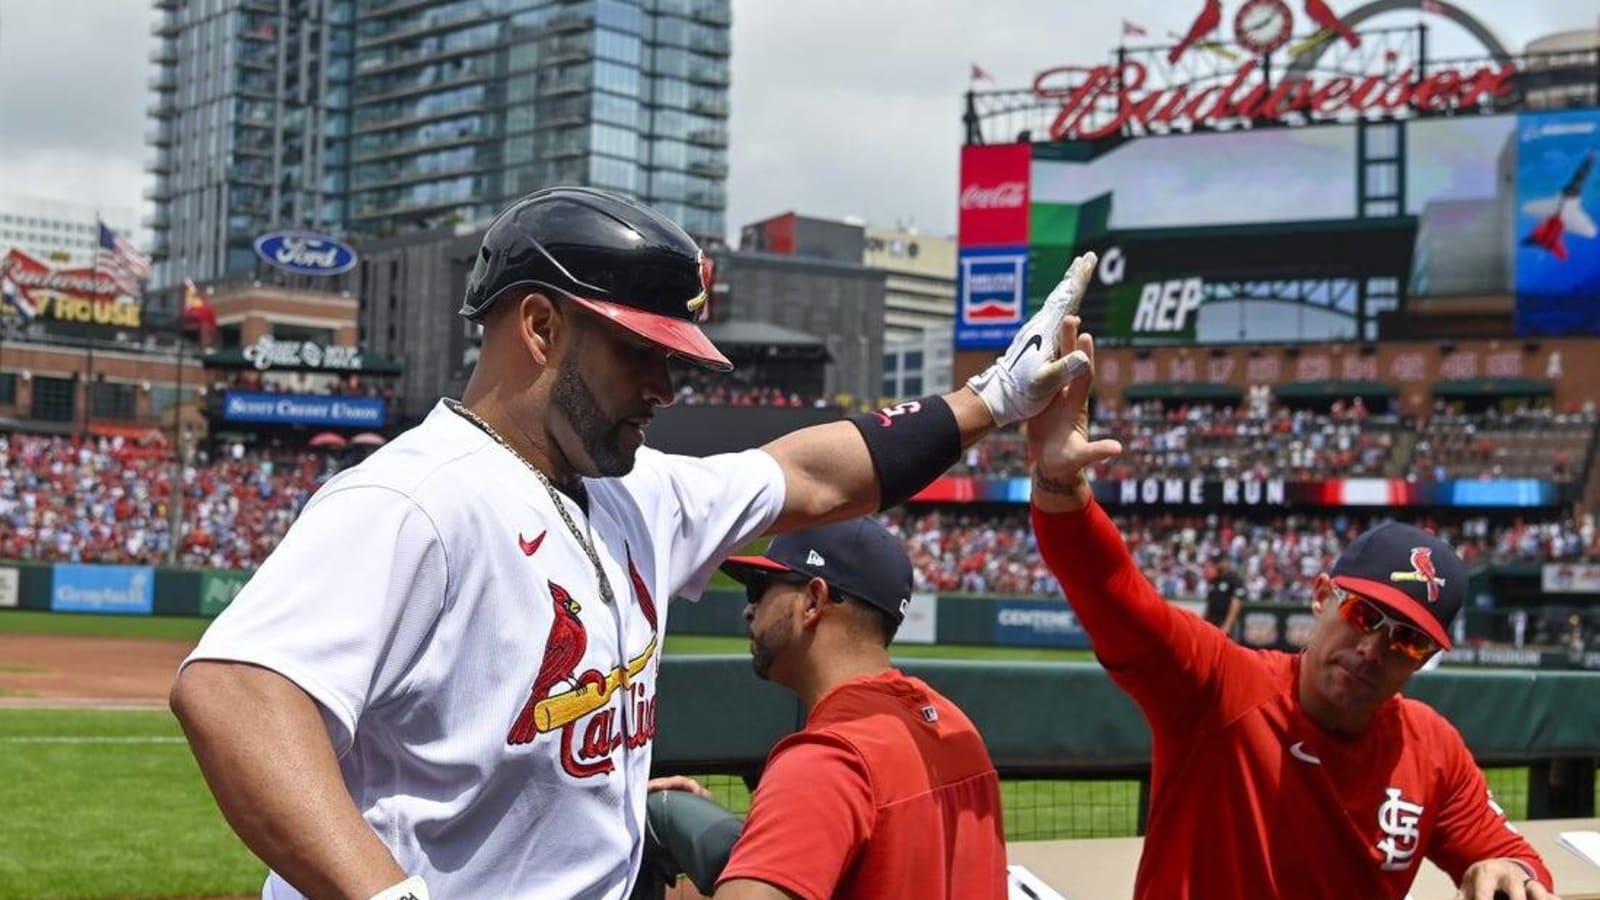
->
[1331, 522, 1467, 650]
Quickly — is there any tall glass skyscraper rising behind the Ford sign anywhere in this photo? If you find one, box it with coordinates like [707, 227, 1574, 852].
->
[149, 0, 731, 285]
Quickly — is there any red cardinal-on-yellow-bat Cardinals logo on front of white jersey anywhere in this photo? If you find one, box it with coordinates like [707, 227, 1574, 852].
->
[506, 551, 659, 778]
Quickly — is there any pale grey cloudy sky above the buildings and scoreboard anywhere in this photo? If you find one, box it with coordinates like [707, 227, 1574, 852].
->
[0, 0, 1595, 241]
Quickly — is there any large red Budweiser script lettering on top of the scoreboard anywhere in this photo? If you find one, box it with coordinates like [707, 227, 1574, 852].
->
[1030, 59, 1517, 140]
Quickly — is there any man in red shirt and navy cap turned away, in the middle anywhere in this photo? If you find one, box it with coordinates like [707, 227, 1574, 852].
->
[715, 519, 1006, 900]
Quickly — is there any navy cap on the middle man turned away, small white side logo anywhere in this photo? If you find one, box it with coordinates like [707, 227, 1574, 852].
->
[722, 519, 912, 625]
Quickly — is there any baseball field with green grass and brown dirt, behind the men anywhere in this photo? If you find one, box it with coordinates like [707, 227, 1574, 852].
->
[0, 610, 1525, 900]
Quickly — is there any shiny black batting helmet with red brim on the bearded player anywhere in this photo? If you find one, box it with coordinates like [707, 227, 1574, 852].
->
[461, 187, 733, 372]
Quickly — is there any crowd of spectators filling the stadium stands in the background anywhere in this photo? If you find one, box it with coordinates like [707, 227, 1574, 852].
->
[0, 397, 1600, 602]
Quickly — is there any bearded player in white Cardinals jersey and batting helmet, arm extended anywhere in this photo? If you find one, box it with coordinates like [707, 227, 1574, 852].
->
[171, 187, 1093, 900]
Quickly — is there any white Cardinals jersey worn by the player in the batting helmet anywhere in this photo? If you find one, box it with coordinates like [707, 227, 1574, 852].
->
[184, 404, 784, 900]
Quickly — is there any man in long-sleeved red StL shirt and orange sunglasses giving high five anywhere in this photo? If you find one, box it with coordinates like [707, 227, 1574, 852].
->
[1029, 310, 1554, 900]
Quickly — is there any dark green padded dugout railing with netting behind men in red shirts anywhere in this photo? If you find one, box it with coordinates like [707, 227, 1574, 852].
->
[654, 655, 1600, 839]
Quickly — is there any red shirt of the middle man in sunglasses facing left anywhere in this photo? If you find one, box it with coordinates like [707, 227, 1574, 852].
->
[718, 669, 1006, 900]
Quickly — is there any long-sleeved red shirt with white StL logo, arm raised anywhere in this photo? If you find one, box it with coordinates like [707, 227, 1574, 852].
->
[1034, 503, 1552, 900]
